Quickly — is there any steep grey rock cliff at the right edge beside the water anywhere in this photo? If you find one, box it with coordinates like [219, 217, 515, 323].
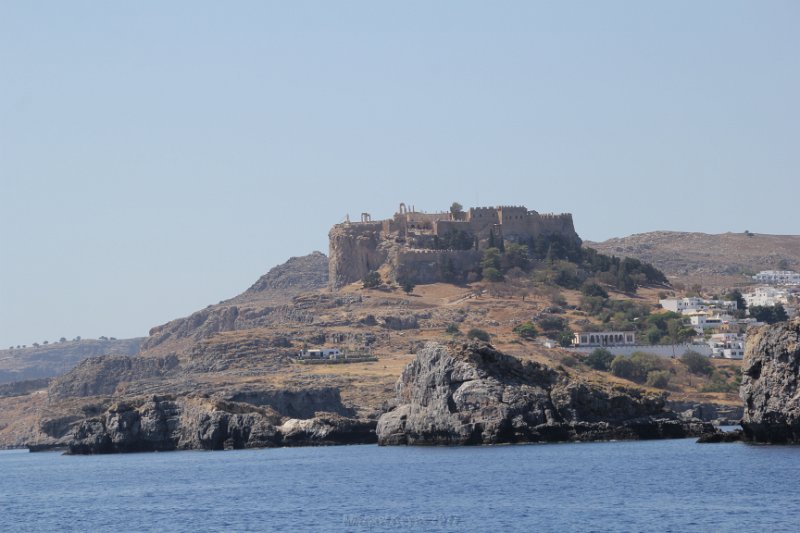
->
[739, 318, 800, 443]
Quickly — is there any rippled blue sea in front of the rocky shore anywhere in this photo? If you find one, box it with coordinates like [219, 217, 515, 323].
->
[0, 439, 800, 533]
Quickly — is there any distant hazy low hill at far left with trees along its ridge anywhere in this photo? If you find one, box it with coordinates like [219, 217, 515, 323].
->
[0, 338, 144, 383]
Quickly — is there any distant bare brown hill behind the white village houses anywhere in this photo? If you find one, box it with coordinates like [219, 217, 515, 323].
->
[584, 231, 800, 288]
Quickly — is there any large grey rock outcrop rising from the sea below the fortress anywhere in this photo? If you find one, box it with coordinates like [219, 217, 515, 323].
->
[377, 343, 711, 445]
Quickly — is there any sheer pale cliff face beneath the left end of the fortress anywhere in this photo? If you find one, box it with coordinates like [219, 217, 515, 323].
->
[328, 223, 388, 289]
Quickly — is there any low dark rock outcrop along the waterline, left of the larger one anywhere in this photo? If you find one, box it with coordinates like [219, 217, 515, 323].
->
[57, 396, 376, 454]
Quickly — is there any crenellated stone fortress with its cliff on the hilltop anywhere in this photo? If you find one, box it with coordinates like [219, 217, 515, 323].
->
[328, 203, 580, 290]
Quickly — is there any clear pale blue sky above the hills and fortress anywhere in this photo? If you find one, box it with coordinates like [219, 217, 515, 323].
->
[0, 0, 800, 347]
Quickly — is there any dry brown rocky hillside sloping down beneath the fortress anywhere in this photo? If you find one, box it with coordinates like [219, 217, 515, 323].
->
[0, 249, 737, 446]
